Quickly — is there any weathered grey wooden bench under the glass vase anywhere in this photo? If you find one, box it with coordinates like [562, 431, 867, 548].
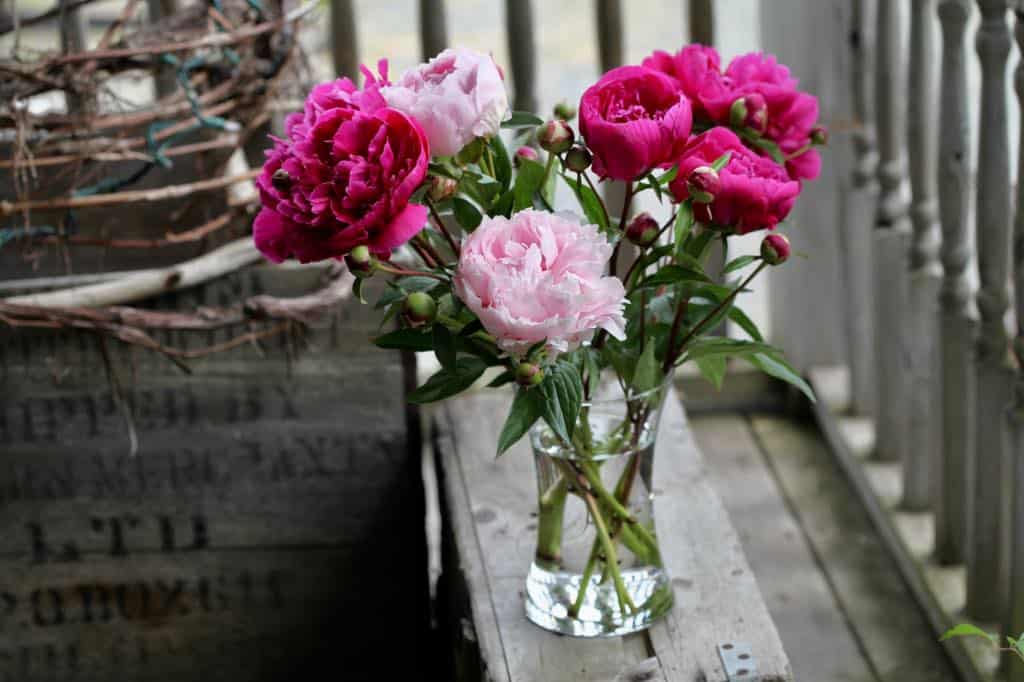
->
[433, 392, 793, 682]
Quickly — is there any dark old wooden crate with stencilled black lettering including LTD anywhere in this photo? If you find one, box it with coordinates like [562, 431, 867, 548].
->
[0, 268, 429, 682]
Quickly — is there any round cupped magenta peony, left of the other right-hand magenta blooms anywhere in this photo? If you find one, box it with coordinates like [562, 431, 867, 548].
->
[580, 67, 693, 180]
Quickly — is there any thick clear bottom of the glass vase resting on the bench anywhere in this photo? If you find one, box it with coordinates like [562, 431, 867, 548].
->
[526, 562, 673, 637]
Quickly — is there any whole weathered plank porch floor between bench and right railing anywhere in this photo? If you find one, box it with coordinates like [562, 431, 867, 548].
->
[689, 399, 957, 682]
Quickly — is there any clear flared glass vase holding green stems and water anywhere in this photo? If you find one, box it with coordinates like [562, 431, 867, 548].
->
[526, 382, 673, 637]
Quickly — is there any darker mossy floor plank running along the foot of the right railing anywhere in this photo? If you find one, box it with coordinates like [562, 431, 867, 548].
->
[752, 416, 957, 682]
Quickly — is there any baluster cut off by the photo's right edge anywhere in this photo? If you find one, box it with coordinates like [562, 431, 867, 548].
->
[1004, 4, 1024, 682]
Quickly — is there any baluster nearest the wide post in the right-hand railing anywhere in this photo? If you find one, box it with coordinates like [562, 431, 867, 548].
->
[841, 0, 879, 416]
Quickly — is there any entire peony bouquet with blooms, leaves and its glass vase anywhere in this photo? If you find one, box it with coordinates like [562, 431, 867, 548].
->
[253, 45, 825, 635]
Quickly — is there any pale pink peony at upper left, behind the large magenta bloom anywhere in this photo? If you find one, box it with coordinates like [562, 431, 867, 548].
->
[381, 47, 509, 157]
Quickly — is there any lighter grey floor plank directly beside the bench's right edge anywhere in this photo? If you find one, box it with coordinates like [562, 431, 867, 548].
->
[690, 415, 874, 681]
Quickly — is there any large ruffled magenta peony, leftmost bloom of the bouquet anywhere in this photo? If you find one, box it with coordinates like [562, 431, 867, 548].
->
[253, 62, 430, 262]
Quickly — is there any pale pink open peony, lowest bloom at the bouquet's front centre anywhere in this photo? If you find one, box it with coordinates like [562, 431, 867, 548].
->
[455, 210, 626, 354]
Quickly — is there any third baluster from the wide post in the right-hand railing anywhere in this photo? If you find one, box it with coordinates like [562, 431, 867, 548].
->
[903, 0, 940, 510]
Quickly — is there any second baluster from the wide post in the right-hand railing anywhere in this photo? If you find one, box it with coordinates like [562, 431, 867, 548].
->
[874, 0, 909, 462]
